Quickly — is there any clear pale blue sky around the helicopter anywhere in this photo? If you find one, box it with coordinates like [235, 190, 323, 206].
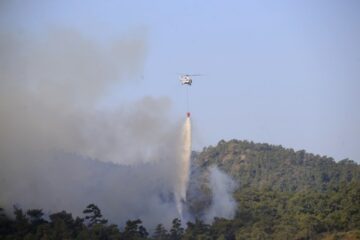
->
[0, 0, 360, 162]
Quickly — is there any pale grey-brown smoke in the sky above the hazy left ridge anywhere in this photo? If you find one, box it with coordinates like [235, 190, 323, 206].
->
[0, 30, 174, 163]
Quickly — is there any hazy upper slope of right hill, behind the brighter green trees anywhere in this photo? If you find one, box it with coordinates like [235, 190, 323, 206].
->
[194, 140, 360, 192]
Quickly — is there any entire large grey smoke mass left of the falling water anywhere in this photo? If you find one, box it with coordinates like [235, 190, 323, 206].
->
[0, 29, 236, 226]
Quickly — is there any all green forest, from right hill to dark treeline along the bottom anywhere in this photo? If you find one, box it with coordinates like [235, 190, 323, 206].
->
[0, 140, 360, 240]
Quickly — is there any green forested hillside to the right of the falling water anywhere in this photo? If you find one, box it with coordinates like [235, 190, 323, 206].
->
[189, 140, 360, 239]
